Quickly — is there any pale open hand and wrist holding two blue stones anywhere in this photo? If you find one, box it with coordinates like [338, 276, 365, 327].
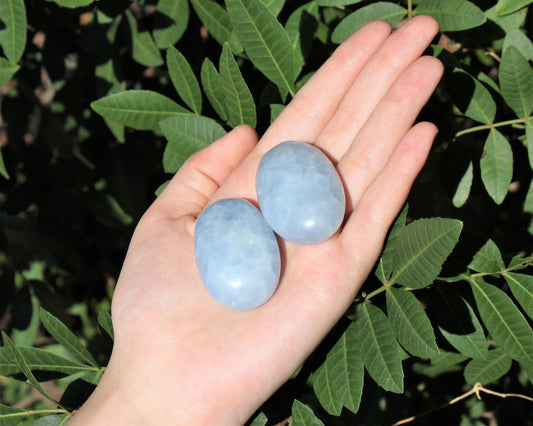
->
[69, 16, 443, 425]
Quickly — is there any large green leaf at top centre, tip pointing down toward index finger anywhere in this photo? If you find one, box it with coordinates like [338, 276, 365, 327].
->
[226, 0, 296, 95]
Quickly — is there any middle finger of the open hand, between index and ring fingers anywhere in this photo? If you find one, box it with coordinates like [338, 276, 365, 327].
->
[316, 16, 439, 160]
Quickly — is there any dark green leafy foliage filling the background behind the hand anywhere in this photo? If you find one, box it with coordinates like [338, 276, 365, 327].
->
[0, 0, 533, 425]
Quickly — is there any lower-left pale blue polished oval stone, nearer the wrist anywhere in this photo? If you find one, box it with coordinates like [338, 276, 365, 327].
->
[194, 199, 281, 310]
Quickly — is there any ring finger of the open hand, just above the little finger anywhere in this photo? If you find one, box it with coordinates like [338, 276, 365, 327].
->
[337, 57, 443, 214]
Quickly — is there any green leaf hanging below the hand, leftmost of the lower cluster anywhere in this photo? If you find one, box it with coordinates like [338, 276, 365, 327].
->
[313, 323, 365, 416]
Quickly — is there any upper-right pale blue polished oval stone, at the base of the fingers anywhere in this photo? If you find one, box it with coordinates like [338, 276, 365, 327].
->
[256, 141, 346, 244]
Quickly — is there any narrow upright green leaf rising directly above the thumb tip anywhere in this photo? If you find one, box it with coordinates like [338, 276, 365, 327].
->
[219, 43, 256, 127]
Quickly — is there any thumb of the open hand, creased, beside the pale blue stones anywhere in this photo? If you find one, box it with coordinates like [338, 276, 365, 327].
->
[152, 125, 258, 218]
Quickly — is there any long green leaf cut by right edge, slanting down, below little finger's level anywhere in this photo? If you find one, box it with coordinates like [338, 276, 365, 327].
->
[470, 277, 533, 363]
